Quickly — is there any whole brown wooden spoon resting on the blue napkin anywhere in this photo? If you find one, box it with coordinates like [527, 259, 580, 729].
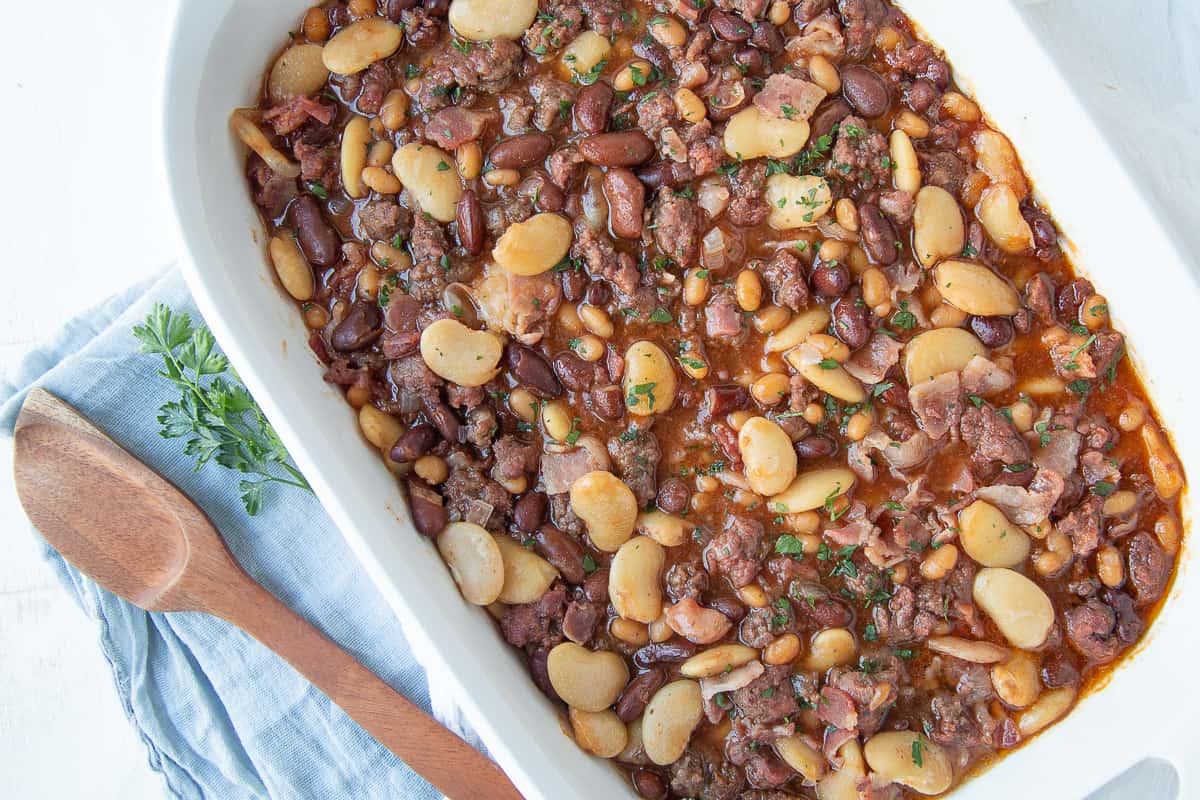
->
[13, 389, 521, 800]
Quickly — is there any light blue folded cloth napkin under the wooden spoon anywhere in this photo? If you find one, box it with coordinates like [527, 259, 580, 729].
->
[0, 270, 480, 800]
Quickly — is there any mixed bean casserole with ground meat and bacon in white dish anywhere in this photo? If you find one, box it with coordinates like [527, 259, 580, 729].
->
[232, 0, 1183, 800]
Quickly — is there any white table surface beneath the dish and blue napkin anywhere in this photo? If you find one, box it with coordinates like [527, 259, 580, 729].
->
[0, 0, 1200, 800]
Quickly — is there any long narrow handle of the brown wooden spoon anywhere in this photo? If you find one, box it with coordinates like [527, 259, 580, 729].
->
[205, 571, 522, 800]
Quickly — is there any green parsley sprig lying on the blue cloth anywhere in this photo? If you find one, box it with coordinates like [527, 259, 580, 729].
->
[133, 303, 312, 516]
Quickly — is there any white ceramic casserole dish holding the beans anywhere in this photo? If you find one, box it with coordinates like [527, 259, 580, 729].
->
[163, 0, 1200, 800]
